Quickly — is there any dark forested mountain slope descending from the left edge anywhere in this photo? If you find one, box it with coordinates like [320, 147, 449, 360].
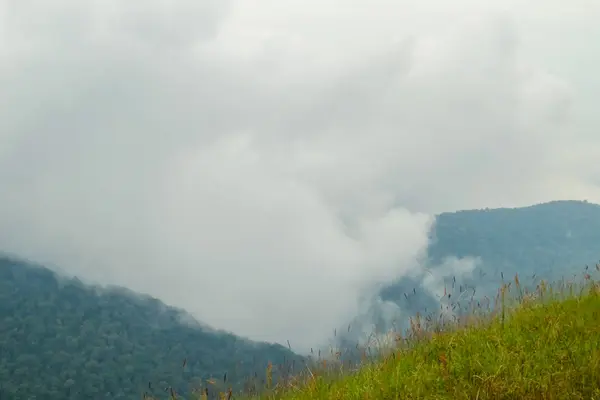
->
[0, 257, 302, 400]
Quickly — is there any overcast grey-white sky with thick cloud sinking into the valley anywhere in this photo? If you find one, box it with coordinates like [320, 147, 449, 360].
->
[0, 0, 600, 351]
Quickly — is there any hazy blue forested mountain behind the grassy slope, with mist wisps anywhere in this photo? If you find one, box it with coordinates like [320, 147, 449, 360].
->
[360, 201, 600, 345]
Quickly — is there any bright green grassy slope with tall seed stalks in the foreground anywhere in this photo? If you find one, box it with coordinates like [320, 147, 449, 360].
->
[243, 273, 600, 400]
